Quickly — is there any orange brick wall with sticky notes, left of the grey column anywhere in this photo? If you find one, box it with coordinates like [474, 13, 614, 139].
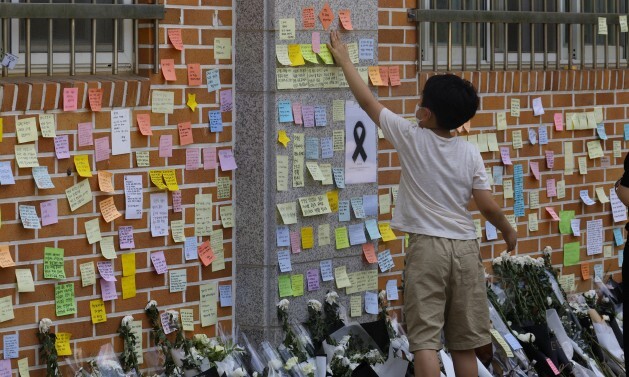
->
[0, 0, 234, 376]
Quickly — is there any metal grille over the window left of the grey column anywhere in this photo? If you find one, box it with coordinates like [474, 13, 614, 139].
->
[0, 0, 164, 77]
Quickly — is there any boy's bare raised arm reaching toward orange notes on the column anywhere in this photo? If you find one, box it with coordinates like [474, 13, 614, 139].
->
[328, 30, 384, 126]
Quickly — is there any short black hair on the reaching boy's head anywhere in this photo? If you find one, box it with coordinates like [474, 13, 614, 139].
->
[421, 74, 479, 130]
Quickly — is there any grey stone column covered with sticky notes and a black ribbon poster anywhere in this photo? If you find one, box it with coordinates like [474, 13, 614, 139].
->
[234, 0, 378, 343]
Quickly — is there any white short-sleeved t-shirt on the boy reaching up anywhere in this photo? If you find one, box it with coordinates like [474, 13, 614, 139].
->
[380, 108, 491, 240]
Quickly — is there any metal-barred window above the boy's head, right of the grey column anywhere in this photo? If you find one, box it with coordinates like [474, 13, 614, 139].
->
[408, 0, 629, 71]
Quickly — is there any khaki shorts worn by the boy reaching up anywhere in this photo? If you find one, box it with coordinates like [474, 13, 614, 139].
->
[404, 234, 491, 352]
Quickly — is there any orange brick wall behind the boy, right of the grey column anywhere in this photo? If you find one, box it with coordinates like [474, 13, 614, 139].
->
[378, 0, 629, 324]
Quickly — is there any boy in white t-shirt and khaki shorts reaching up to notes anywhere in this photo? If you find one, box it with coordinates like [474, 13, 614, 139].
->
[328, 31, 517, 377]
